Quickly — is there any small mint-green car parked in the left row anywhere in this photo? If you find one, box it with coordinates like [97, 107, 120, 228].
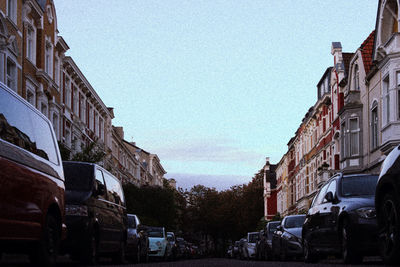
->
[147, 227, 172, 260]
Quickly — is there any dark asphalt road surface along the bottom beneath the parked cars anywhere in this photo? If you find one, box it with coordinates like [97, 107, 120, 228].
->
[0, 255, 383, 267]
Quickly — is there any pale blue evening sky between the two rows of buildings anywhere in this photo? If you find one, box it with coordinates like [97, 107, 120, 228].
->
[54, 0, 378, 190]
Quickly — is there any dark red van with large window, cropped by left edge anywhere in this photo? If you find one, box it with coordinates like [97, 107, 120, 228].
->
[0, 83, 66, 266]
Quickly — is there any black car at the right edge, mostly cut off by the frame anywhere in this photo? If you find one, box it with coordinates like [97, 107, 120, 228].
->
[375, 146, 400, 265]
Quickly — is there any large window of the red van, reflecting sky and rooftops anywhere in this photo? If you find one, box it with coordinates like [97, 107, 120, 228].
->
[0, 89, 59, 164]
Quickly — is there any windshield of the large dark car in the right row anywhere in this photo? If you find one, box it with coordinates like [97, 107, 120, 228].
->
[342, 175, 378, 197]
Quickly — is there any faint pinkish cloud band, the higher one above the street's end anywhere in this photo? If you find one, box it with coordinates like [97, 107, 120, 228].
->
[156, 138, 263, 165]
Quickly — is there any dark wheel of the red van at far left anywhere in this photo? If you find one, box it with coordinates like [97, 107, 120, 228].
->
[29, 214, 61, 266]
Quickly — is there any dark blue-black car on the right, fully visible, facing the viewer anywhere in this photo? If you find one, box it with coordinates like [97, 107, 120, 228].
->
[302, 173, 378, 263]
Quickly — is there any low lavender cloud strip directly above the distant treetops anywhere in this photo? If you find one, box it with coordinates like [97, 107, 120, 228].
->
[167, 173, 251, 191]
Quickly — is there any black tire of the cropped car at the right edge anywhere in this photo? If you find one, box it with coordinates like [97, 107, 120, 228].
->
[379, 192, 400, 264]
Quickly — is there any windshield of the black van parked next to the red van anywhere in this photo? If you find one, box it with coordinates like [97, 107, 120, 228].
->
[63, 162, 94, 191]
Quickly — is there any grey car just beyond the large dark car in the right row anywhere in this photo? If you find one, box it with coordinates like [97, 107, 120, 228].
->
[272, 214, 306, 260]
